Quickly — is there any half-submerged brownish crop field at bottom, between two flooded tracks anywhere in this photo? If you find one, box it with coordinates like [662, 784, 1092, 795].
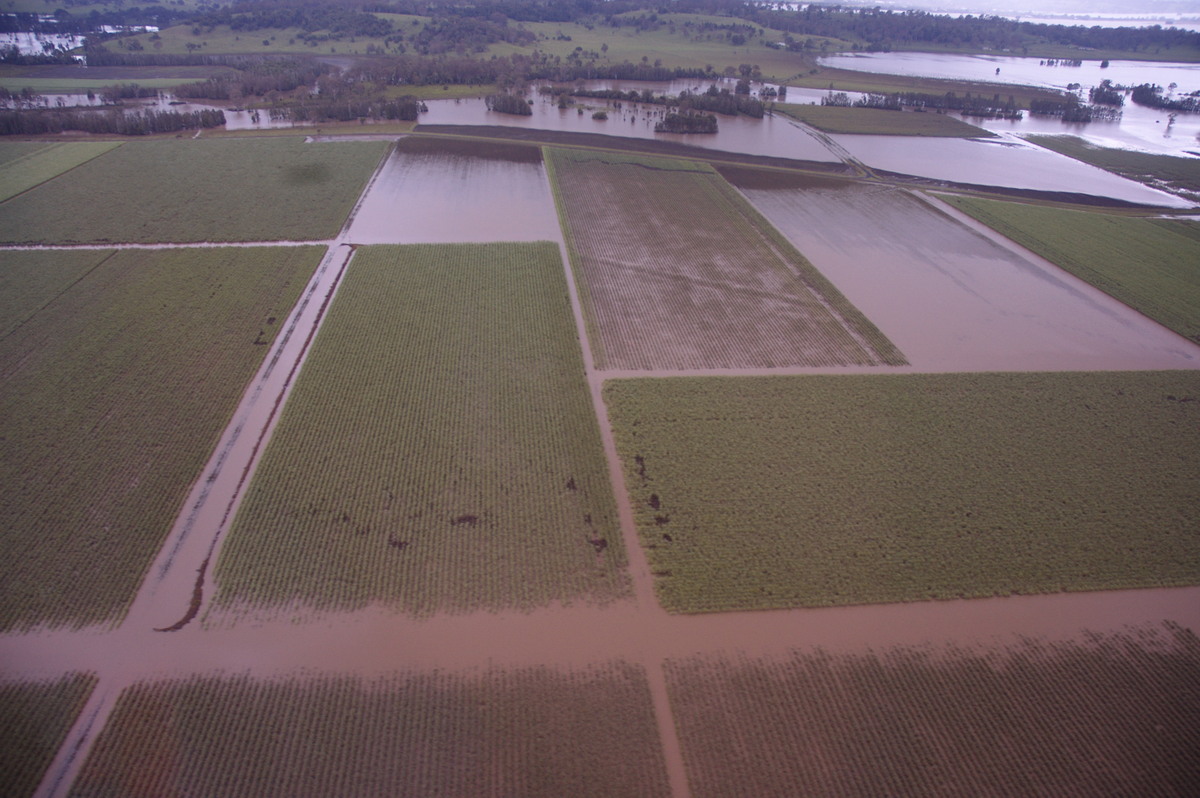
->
[70, 662, 670, 798]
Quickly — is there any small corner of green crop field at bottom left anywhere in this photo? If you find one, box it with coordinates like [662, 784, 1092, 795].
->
[0, 673, 96, 798]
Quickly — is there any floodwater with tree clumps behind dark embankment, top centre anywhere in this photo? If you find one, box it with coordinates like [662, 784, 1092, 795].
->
[420, 92, 838, 162]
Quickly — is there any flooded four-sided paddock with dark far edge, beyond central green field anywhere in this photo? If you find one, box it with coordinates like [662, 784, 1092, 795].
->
[347, 137, 559, 244]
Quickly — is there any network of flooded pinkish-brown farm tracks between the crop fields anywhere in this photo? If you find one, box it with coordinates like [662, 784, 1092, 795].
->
[0, 133, 1200, 798]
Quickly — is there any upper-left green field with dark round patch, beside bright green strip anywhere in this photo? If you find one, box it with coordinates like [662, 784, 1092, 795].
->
[0, 137, 388, 244]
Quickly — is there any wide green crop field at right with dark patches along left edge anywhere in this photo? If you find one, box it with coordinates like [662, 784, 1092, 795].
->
[605, 371, 1200, 612]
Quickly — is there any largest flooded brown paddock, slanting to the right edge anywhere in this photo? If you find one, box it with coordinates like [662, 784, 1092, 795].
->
[743, 181, 1200, 372]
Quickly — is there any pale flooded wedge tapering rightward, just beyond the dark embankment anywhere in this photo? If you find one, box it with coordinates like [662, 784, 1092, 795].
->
[832, 134, 1193, 208]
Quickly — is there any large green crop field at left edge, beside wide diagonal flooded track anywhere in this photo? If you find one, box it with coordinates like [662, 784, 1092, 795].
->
[0, 247, 322, 629]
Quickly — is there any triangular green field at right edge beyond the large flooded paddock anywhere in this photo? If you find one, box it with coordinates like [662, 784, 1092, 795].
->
[943, 197, 1200, 342]
